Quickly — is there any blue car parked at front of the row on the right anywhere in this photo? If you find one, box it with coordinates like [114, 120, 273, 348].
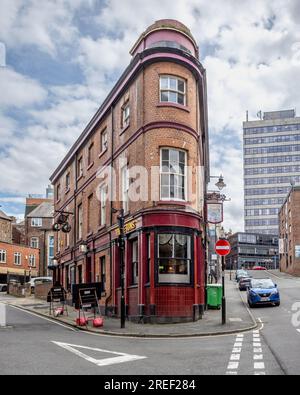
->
[248, 279, 280, 308]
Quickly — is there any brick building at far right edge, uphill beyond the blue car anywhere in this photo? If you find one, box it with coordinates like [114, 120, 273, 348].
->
[279, 186, 300, 276]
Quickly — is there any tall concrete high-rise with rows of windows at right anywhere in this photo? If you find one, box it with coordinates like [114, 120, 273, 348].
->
[243, 110, 300, 235]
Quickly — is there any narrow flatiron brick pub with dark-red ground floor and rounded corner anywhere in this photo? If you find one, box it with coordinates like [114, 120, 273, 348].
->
[51, 20, 209, 322]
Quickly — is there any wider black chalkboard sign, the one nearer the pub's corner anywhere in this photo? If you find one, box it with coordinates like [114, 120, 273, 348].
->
[72, 283, 103, 309]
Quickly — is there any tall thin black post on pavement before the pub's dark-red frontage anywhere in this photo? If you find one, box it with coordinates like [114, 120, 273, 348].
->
[112, 208, 126, 329]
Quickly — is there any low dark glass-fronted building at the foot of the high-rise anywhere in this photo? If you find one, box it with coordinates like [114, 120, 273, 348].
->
[226, 233, 279, 270]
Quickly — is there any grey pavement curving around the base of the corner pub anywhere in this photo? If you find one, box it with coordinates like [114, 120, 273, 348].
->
[1, 274, 257, 338]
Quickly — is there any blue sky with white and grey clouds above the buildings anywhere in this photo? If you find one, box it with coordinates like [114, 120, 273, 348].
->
[0, 0, 300, 231]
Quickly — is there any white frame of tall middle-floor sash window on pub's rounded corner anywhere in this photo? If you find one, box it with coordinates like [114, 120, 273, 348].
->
[160, 147, 188, 202]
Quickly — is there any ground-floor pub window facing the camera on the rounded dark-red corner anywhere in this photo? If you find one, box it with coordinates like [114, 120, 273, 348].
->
[158, 234, 191, 284]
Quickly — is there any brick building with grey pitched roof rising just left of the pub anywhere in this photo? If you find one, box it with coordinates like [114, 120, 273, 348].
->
[25, 198, 54, 276]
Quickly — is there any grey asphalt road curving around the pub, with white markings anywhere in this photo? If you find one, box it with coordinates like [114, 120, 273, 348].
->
[0, 274, 300, 376]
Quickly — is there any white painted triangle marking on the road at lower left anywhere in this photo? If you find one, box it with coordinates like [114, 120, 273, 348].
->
[52, 341, 147, 366]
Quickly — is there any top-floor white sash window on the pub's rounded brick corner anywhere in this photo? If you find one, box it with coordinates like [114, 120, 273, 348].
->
[160, 75, 186, 106]
